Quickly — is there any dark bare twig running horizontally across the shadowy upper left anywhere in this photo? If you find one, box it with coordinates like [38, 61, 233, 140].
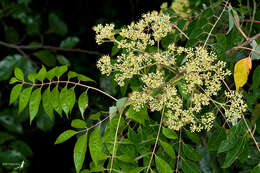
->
[0, 41, 103, 56]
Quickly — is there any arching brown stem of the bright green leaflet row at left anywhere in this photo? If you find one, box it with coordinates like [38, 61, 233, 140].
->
[21, 80, 117, 101]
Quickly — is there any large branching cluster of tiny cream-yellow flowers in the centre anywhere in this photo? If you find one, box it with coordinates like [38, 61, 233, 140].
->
[94, 12, 246, 132]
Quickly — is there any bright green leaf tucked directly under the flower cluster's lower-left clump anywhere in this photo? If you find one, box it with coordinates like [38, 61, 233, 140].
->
[128, 106, 149, 125]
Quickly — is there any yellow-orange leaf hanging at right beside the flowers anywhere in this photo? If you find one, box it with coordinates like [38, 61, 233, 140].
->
[234, 56, 252, 91]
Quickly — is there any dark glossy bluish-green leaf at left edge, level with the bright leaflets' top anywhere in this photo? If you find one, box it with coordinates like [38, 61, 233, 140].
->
[0, 54, 23, 81]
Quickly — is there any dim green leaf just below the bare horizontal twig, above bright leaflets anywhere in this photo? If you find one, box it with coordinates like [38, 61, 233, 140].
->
[33, 50, 56, 67]
